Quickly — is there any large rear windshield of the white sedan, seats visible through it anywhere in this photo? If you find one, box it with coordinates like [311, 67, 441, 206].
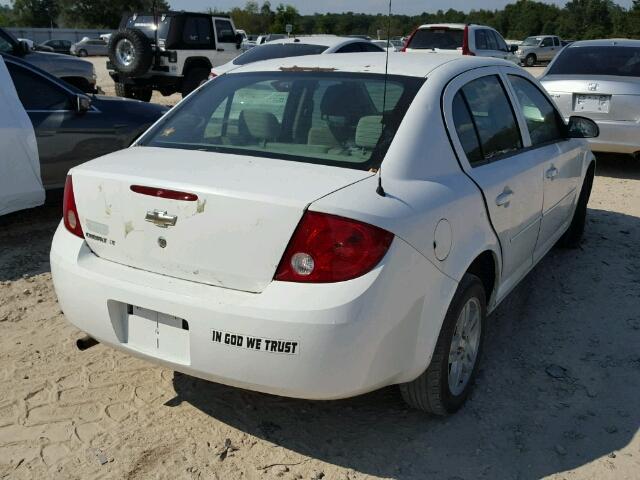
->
[138, 72, 424, 170]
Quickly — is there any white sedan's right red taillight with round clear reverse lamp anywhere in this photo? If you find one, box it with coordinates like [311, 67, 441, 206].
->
[275, 211, 393, 283]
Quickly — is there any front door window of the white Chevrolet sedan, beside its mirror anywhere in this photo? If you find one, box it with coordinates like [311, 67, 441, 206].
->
[509, 75, 565, 146]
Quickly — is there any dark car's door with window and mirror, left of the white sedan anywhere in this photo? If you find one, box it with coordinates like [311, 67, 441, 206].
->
[7, 62, 117, 189]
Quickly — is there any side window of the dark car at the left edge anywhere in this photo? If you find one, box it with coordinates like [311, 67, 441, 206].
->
[7, 62, 71, 111]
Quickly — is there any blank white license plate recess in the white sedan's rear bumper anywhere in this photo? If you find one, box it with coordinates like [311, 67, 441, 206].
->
[126, 305, 189, 364]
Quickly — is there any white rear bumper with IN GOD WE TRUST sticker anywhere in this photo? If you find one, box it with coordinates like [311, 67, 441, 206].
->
[51, 225, 456, 399]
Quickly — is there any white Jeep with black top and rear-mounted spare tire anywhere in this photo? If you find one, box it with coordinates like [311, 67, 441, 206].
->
[107, 12, 242, 102]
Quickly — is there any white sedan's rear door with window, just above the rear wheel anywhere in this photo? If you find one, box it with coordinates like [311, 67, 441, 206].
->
[443, 67, 543, 301]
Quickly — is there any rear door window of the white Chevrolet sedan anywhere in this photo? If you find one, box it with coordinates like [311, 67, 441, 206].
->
[458, 75, 522, 163]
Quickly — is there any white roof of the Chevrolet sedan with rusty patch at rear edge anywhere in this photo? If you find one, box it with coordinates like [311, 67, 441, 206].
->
[229, 52, 513, 77]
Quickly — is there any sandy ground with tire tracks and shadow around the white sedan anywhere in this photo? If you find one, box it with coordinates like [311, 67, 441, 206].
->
[0, 58, 640, 480]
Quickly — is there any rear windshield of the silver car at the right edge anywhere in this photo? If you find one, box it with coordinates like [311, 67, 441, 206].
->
[547, 46, 640, 77]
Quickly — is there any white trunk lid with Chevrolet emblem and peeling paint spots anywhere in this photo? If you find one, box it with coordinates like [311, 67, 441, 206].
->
[71, 147, 372, 292]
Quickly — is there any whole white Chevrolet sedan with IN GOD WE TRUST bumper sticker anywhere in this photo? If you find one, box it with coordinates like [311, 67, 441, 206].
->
[51, 53, 597, 414]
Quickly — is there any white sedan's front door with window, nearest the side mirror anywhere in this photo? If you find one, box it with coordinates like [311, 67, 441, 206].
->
[507, 70, 584, 262]
